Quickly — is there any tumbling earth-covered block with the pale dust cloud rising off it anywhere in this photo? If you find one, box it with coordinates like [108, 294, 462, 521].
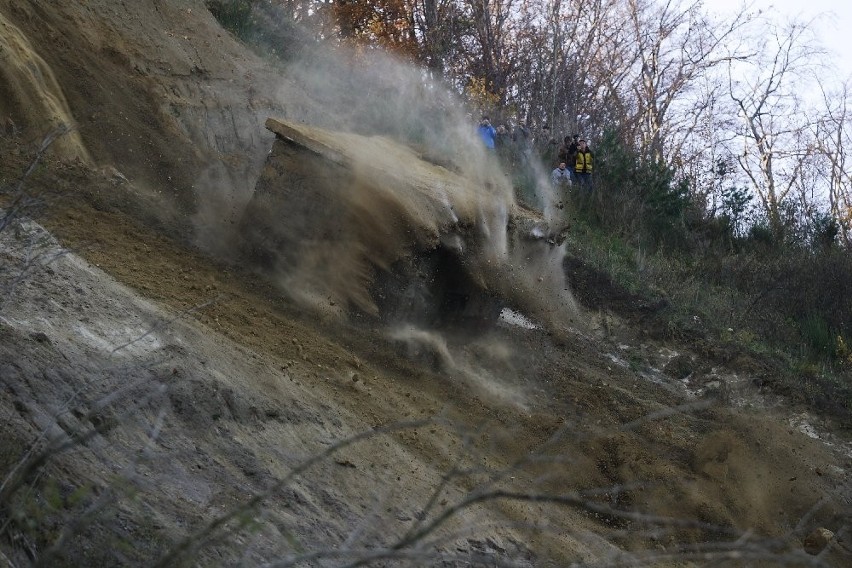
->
[188, 17, 579, 377]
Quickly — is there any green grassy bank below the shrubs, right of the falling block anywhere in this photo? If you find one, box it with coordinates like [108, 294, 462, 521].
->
[566, 200, 852, 428]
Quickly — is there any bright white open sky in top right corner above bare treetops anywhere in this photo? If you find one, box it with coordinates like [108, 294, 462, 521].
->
[704, 0, 852, 76]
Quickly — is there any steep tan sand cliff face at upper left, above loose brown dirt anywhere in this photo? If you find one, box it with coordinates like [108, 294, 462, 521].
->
[0, 0, 280, 217]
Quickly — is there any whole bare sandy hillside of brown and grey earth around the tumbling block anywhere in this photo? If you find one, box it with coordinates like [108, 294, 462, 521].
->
[0, 0, 852, 566]
